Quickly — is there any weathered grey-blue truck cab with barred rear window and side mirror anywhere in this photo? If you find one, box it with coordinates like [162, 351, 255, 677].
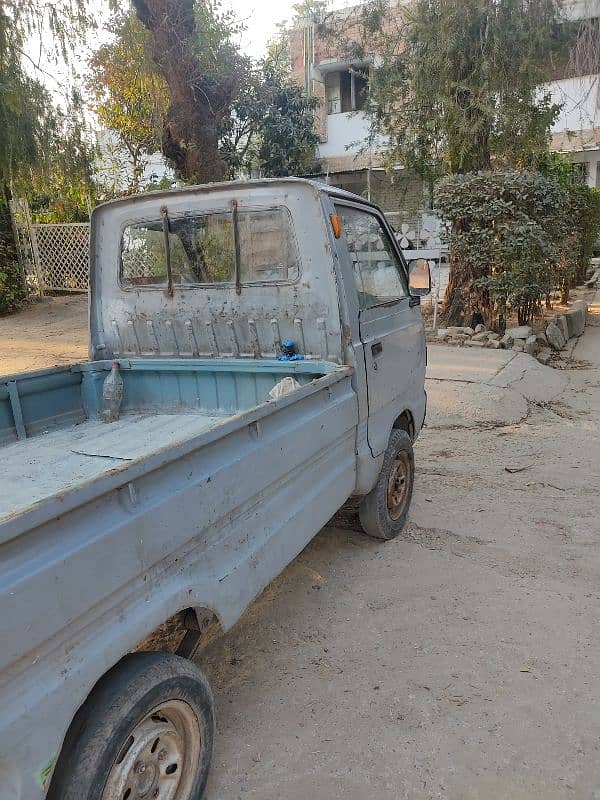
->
[90, 178, 430, 493]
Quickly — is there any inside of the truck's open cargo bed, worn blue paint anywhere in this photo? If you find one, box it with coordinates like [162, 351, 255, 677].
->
[0, 359, 339, 523]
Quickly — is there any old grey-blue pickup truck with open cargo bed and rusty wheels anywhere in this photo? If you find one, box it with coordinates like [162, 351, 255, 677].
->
[0, 179, 429, 800]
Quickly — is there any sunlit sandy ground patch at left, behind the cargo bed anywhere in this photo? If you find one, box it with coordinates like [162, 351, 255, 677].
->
[0, 295, 87, 375]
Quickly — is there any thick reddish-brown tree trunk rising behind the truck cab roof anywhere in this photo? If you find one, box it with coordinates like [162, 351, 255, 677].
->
[133, 0, 226, 183]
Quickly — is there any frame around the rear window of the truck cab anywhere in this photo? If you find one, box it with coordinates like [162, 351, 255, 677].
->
[117, 205, 302, 292]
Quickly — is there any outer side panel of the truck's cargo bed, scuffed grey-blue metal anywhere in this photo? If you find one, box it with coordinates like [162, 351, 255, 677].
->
[0, 371, 357, 800]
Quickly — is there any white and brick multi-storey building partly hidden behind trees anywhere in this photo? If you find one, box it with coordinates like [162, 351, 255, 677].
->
[290, 0, 600, 192]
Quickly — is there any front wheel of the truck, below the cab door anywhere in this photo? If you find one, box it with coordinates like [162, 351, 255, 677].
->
[358, 430, 415, 539]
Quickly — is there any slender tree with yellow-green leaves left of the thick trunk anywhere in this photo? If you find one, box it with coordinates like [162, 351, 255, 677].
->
[87, 11, 168, 192]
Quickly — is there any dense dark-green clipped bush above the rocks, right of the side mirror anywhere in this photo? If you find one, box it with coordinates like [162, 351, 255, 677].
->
[437, 170, 574, 328]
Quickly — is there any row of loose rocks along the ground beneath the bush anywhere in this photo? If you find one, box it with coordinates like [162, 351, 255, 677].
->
[437, 300, 587, 364]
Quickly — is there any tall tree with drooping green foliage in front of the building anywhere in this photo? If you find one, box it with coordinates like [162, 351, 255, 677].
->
[346, 0, 566, 178]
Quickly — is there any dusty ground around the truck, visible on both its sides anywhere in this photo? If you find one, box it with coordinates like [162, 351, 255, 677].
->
[0, 293, 600, 800]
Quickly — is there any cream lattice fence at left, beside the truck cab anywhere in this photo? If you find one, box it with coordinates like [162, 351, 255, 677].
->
[11, 200, 90, 294]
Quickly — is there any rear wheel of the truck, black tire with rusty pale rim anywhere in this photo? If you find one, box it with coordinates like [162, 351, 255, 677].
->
[47, 653, 215, 800]
